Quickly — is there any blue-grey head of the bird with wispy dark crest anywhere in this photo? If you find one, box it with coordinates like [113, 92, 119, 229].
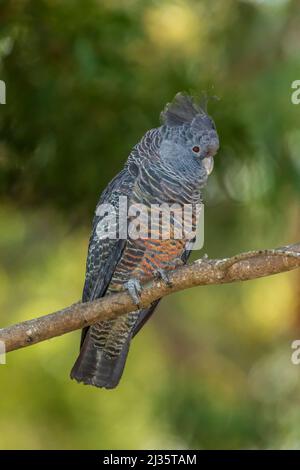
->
[160, 93, 219, 183]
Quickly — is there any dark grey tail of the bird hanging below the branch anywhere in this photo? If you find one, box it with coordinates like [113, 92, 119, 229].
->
[71, 329, 131, 388]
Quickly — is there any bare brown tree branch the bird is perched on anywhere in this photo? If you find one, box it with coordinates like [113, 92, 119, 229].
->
[0, 243, 300, 352]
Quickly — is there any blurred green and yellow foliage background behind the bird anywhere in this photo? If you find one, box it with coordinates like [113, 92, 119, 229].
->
[0, 0, 300, 449]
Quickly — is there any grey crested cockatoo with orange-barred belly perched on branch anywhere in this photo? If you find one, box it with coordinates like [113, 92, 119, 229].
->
[71, 92, 219, 389]
